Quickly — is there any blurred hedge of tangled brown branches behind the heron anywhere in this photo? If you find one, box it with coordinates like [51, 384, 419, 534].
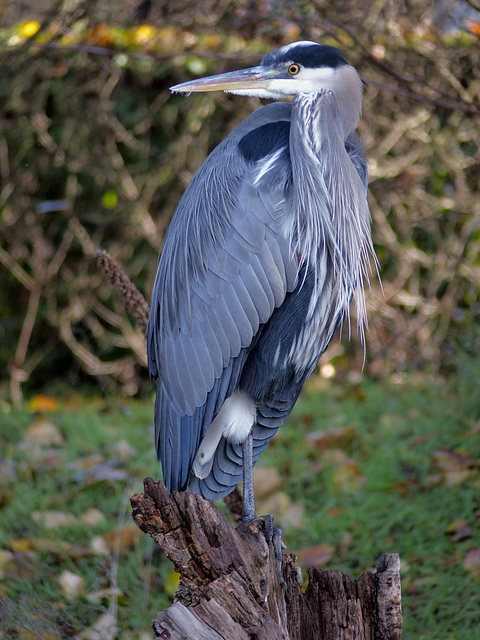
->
[0, 0, 480, 400]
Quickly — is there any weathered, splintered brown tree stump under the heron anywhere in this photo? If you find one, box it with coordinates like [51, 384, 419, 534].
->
[131, 478, 402, 640]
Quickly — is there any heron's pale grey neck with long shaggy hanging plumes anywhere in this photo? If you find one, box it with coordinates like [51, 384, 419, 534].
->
[290, 65, 373, 335]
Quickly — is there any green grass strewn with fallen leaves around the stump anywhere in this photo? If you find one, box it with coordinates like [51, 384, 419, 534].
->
[0, 365, 480, 640]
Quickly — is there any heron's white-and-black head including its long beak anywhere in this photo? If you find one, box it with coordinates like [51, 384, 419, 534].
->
[171, 41, 362, 99]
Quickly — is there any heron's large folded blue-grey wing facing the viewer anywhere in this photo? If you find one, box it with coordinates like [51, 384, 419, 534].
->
[148, 103, 298, 490]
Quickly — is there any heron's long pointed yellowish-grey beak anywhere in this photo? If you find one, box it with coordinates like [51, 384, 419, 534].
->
[170, 66, 278, 93]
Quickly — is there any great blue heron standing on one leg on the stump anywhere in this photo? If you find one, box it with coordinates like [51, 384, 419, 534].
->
[148, 41, 373, 520]
